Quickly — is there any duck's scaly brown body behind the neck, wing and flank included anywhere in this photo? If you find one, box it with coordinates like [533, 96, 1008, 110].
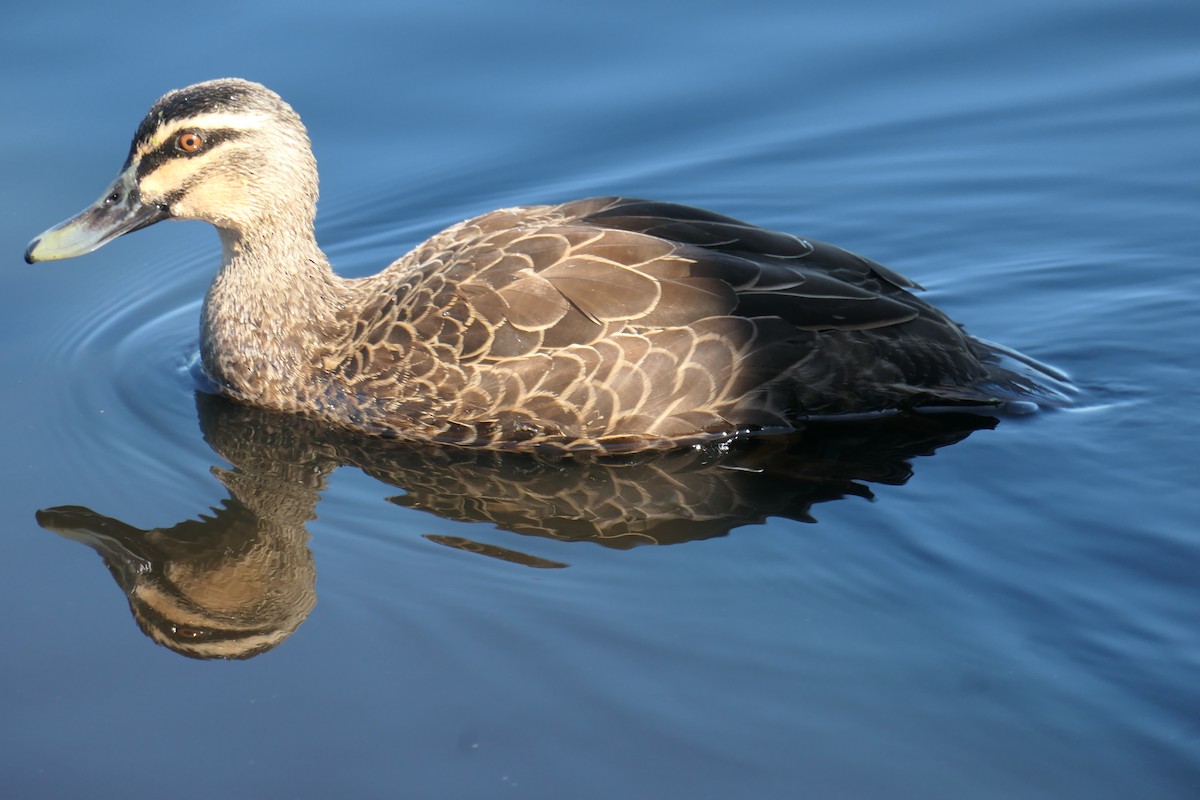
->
[322, 198, 1060, 450]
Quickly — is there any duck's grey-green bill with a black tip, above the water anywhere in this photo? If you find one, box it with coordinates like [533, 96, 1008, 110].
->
[25, 170, 167, 264]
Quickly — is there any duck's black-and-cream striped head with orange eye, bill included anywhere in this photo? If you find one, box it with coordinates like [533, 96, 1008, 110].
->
[25, 78, 317, 264]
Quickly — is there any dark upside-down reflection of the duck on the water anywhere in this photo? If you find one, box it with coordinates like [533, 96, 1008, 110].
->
[37, 393, 995, 658]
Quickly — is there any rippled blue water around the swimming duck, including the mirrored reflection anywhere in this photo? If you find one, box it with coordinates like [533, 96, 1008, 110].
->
[0, 0, 1200, 798]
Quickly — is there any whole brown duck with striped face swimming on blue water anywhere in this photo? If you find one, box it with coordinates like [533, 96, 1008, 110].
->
[25, 78, 1067, 453]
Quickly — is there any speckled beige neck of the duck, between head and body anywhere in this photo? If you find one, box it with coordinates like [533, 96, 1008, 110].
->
[200, 225, 344, 411]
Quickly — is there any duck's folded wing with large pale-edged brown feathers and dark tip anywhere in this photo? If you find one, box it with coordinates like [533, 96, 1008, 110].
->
[397, 198, 928, 360]
